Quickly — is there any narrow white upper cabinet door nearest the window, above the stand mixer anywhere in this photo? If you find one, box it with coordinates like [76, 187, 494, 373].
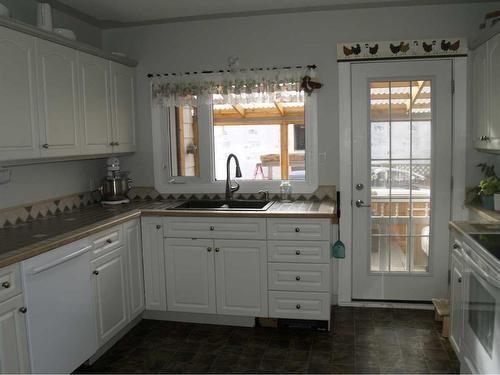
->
[110, 62, 135, 152]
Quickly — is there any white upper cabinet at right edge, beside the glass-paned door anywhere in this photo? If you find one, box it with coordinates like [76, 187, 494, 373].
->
[472, 34, 500, 152]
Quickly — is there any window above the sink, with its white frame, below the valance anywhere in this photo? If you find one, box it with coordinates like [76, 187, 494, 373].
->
[152, 67, 318, 194]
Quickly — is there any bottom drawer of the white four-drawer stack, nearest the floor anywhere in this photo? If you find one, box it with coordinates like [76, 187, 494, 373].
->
[269, 291, 330, 320]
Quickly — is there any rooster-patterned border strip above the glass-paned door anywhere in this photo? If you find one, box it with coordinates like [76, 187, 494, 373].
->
[337, 38, 467, 61]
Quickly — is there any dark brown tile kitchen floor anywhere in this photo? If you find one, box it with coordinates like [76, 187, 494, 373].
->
[76, 307, 459, 373]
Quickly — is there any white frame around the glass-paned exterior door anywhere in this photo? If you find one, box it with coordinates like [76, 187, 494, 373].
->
[336, 57, 468, 308]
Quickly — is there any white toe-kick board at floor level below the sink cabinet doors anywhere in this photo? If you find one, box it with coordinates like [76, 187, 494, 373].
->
[142, 310, 255, 327]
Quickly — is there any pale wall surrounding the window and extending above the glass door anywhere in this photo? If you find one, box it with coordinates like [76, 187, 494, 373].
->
[103, 2, 500, 192]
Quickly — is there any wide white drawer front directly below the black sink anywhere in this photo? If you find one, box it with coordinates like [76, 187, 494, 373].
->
[163, 217, 266, 240]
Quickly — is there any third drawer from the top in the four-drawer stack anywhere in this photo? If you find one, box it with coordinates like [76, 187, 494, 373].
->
[268, 263, 330, 292]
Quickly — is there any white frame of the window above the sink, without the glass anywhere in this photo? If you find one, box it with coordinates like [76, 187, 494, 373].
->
[151, 93, 318, 194]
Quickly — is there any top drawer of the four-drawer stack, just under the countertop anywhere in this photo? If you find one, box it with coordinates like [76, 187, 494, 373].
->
[267, 219, 331, 241]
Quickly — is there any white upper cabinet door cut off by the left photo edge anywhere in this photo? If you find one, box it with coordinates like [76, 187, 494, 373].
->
[0, 27, 40, 160]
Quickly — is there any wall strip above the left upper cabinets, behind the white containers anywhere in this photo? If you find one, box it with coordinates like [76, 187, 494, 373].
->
[0, 0, 102, 48]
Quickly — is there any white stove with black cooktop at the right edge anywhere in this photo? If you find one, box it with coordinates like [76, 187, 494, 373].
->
[462, 238, 500, 374]
